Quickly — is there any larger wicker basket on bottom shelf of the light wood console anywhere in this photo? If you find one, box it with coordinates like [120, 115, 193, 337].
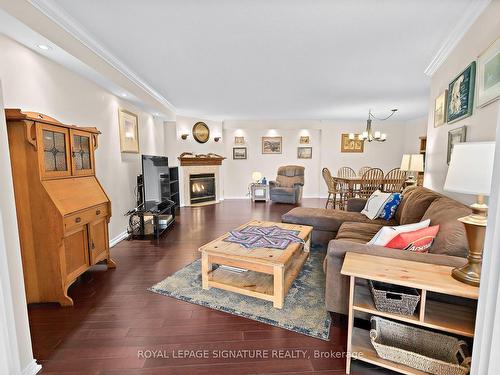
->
[370, 316, 471, 375]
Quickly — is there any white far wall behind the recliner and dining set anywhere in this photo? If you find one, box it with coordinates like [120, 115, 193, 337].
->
[223, 119, 425, 198]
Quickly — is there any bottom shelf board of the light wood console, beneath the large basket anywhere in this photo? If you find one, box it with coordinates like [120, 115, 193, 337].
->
[352, 328, 427, 375]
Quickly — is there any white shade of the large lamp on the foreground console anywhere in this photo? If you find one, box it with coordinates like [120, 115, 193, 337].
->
[444, 142, 495, 195]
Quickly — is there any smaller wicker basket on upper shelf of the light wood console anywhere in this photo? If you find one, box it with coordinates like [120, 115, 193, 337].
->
[368, 280, 420, 315]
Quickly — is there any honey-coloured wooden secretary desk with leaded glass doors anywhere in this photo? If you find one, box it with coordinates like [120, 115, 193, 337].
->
[5, 109, 115, 306]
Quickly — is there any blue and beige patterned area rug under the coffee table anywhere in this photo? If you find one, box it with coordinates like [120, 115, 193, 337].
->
[148, 247, 331, 340]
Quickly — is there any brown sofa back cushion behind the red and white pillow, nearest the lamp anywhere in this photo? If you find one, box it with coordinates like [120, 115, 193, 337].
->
[423, 196, 472, 258]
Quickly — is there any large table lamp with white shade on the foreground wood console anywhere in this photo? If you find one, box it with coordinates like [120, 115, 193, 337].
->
[444, 142, 495, 286]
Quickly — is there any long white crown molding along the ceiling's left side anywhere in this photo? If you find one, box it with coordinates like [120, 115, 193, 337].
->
[27, 0, 176, 113]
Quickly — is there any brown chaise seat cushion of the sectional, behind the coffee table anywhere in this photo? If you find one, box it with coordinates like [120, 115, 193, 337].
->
[281, 207, 396, 233]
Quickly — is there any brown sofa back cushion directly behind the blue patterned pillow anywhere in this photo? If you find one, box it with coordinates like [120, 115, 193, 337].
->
[396, 187, 442, 225]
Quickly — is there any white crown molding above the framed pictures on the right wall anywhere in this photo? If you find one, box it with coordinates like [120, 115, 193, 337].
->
[424, 0, 491, 77]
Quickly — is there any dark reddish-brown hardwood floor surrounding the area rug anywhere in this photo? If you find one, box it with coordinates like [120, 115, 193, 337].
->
[29, 199, 387, 375]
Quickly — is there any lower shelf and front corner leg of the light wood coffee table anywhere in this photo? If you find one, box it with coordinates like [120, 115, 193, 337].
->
[204, 250, 309, 308]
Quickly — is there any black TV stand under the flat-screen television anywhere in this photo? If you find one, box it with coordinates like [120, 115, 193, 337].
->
[129, 200, 175, 241]
